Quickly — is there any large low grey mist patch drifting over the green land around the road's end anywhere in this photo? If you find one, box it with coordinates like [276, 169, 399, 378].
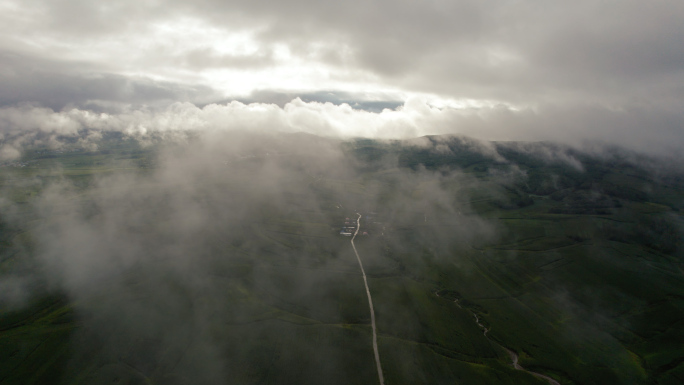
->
[6, 124, 493, 383]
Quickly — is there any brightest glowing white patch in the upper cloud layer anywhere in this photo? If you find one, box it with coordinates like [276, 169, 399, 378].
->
[136, 19, 384, 97]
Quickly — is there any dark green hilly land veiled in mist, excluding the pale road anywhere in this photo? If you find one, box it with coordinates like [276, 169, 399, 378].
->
[0, 131, 684, 384]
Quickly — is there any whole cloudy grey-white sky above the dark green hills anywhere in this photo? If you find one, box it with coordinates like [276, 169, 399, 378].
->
[0, 0, 684, 154]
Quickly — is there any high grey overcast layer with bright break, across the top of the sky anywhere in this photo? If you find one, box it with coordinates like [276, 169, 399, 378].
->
[5, 1, 684, 104]
